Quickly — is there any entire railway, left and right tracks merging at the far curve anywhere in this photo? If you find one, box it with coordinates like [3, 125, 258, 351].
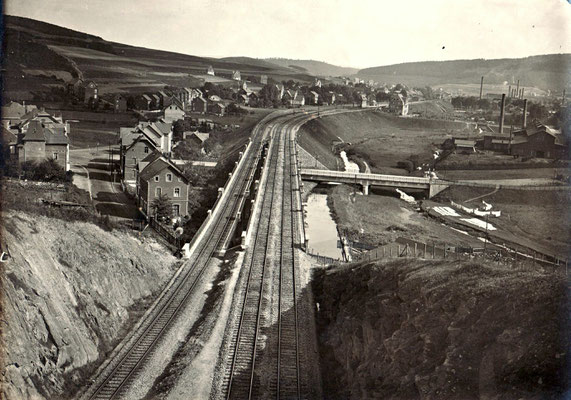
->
[81, 110, 362, 399]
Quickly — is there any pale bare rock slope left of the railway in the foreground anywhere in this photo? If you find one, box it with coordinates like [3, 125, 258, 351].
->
[1, 213, 179, 399]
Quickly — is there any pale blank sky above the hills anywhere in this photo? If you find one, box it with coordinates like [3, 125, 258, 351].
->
[5, 0, 571, 68]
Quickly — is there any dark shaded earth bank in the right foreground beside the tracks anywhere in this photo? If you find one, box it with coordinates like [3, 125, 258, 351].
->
[314, 260, 570, 399]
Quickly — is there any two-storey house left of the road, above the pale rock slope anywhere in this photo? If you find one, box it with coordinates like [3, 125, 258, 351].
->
[15, 119, 70, 171]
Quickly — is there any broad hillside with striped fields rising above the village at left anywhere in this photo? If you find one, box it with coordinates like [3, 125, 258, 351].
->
[2, 15, 313, 100]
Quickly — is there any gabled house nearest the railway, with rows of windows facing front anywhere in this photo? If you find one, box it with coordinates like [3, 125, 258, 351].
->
[136, 155, 189, 218]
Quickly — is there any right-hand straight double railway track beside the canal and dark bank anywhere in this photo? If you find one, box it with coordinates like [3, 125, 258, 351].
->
[223, 117, 304, 399]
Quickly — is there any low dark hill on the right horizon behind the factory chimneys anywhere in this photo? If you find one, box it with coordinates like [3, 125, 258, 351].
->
[357, 54, 571, 91]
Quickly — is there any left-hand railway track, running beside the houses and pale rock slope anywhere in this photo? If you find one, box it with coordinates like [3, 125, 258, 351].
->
[82, 113, 280, 399]
